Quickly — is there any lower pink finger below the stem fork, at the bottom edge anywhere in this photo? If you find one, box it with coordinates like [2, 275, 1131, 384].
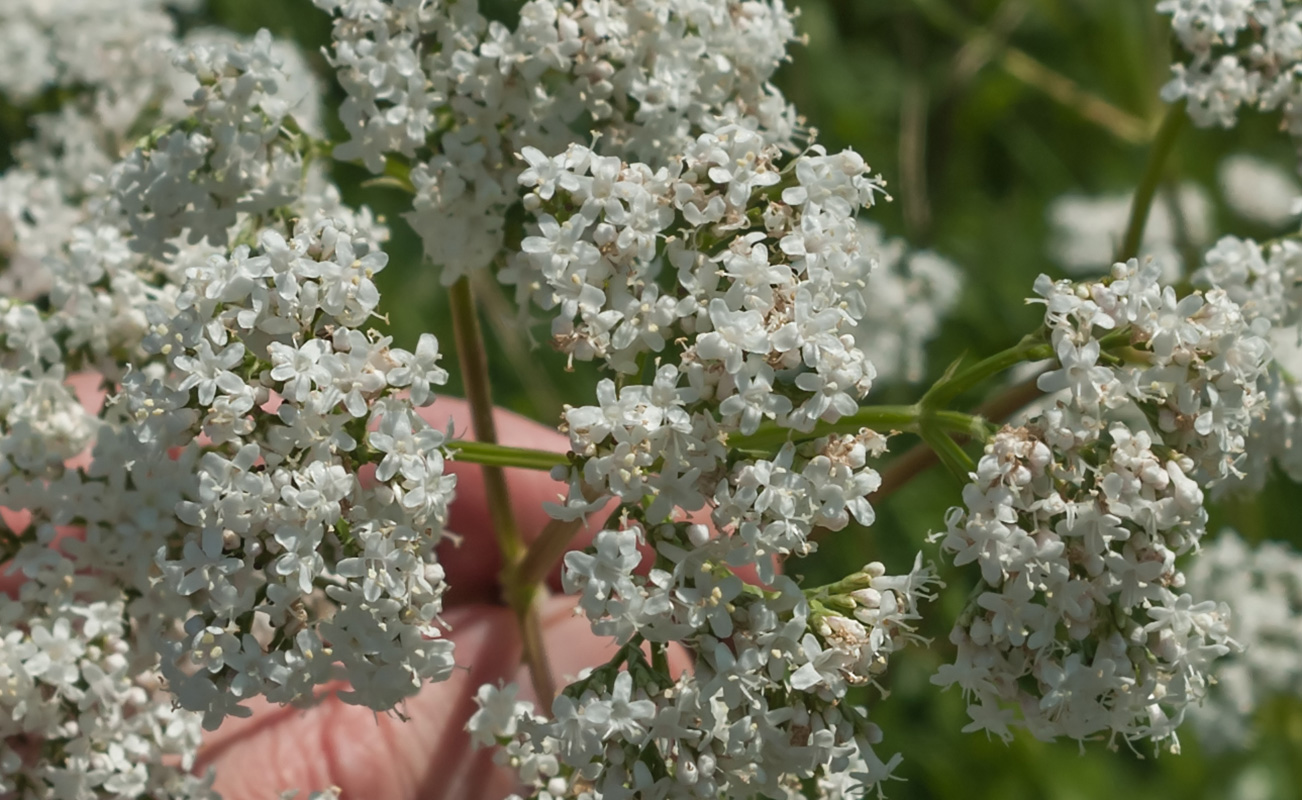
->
[199, 597, 689, 800]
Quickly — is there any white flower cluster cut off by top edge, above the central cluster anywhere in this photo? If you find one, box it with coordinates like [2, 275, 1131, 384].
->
[315, 0, 796, 283]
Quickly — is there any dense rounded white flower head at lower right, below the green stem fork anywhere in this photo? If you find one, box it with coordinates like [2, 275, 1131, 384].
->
[934, 429, 1234, 743]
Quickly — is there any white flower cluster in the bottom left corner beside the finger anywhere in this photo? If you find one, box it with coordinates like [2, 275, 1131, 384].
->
[0, 591, 216, 799]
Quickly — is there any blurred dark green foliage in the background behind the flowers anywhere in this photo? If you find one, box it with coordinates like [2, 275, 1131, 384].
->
[40, 0, 1302, 800]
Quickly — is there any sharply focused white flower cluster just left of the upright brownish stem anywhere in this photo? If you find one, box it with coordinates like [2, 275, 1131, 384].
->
[132, 218, 454, 724]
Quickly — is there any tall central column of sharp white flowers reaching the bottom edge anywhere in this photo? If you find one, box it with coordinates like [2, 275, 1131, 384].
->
[475, 117, 963, 797]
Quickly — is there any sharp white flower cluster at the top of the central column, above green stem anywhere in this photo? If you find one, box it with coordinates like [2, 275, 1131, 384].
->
[518, 125, 880, 419]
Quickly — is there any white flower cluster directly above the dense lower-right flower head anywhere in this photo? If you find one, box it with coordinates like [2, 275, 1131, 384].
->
[1035, 259, 1269, 483]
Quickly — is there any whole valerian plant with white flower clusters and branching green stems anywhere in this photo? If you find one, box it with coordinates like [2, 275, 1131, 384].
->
[0, 0, 1302, 800]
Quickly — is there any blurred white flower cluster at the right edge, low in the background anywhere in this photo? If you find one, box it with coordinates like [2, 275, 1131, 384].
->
[1189, 530, 1302, 750]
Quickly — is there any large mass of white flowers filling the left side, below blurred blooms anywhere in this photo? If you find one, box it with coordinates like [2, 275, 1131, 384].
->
[0, 23, 454, 797]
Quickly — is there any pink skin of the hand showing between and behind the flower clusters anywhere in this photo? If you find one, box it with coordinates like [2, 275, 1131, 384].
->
[0, 375, 770, 800]
